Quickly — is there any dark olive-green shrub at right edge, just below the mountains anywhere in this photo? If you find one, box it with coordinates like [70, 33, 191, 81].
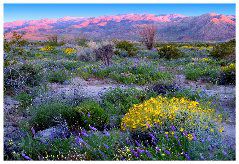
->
[210, 40, 236, 59]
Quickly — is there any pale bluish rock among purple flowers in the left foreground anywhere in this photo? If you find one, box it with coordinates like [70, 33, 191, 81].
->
[34, 123, 70, 144]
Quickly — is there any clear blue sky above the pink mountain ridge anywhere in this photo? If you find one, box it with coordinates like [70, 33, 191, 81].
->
[4, 4, 235, 22]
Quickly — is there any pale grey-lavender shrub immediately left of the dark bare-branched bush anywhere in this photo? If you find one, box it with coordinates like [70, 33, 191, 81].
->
[77, 48, 97, 62]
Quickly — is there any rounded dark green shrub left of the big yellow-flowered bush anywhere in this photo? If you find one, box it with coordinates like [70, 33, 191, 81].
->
[75, 100, 108, 129]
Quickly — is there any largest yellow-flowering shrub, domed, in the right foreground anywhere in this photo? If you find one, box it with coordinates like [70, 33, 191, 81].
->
[121, 96, 218, 131]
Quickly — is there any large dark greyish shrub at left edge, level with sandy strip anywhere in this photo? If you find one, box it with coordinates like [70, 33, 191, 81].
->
[4, 64, 40, 93]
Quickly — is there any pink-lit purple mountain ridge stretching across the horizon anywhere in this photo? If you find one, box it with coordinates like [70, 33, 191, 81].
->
[4, 13, 236, 41]
